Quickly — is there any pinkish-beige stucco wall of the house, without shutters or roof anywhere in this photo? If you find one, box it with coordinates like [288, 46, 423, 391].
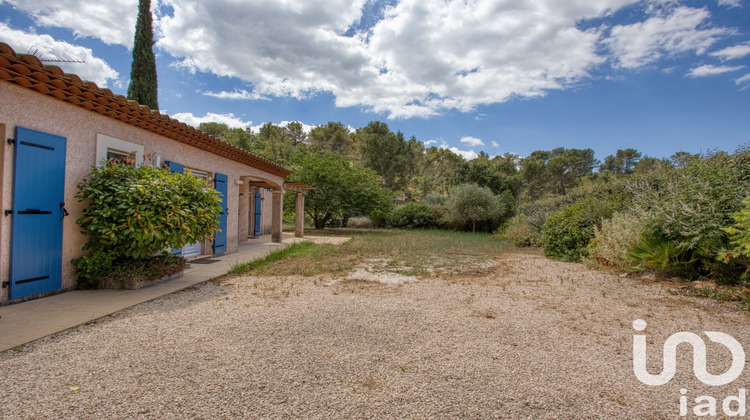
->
[0, 83, 283, 304]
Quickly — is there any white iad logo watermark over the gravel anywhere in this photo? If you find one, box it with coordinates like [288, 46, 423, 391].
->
[633, 319, 746, 416]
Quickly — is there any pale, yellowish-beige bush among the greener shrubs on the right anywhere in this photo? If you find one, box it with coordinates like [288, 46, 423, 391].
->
[588, 212, 643, 269]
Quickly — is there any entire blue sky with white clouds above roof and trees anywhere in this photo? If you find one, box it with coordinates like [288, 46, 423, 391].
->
[0, 0, 750, 160]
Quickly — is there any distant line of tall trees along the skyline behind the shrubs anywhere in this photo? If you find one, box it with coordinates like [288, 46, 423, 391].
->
[199, 121, 664, 210]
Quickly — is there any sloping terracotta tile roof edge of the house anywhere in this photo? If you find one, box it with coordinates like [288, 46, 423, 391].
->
[0, 46, 291, 178]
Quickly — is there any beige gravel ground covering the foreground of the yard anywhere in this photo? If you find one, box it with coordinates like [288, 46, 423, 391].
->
[0, 253, 750, 419]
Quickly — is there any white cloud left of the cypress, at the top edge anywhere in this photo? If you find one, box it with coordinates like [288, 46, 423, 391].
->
[0, 0, 138, 47]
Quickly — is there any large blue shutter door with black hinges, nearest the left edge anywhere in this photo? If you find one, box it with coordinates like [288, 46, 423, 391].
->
[10, 127, 66, 299]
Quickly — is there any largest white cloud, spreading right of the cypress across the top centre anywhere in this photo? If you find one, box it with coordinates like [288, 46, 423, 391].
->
[157, 0, 636, 118]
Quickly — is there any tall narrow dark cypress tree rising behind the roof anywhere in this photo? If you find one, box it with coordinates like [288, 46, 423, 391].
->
[128, 0, 159, 110]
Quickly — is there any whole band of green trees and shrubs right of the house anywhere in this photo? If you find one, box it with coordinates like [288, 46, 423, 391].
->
[200, 121, 750, 284]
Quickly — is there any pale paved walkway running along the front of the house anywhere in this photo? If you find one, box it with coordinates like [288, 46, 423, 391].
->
[0, 233, 349, 351]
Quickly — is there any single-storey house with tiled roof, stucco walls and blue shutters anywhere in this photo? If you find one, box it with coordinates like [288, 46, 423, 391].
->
[0, 43, 310, 305]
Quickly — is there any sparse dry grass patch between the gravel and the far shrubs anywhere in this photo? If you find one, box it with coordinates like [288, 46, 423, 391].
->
[230, 228, 511, 277]
